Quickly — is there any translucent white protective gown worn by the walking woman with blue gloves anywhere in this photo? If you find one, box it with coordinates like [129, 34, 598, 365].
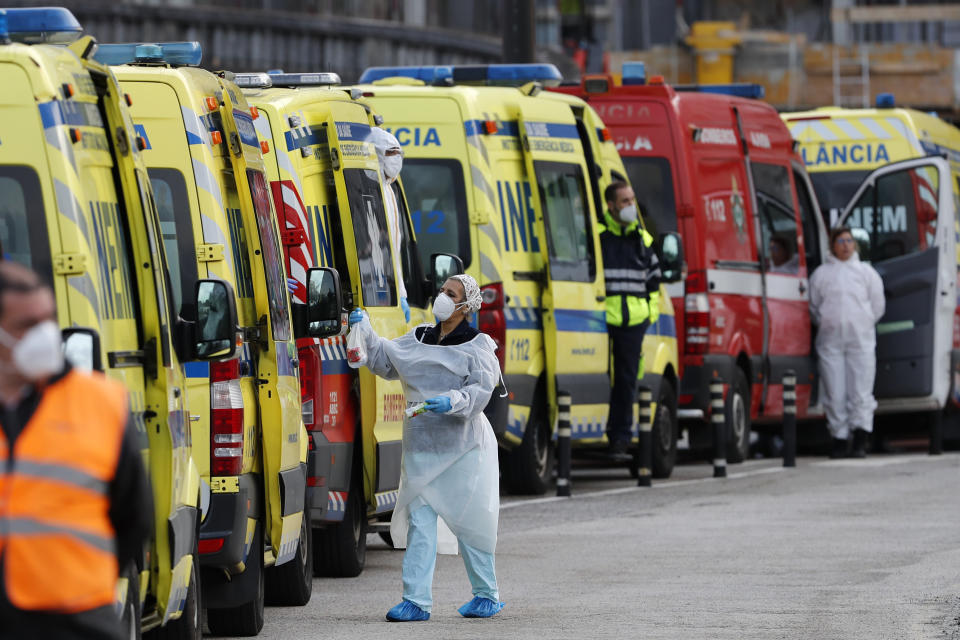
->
[351, 318, 500, 554]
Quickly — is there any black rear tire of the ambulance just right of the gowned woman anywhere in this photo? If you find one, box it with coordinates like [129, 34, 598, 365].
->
[503, 393, 554, 495]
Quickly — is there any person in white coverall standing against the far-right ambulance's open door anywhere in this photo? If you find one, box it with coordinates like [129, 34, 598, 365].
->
[810, 227, 886, 458]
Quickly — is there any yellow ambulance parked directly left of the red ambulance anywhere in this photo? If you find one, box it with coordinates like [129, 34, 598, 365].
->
[358, 65, 680, 493]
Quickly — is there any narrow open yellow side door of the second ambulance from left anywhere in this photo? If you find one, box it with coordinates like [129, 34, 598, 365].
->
[222, 85, 306, 565]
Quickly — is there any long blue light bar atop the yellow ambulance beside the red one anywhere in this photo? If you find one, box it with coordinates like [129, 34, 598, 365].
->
[360, 63, 563, 87]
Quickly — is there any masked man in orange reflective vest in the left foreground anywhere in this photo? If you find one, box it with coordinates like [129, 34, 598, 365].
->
[0, 261, 153, 640]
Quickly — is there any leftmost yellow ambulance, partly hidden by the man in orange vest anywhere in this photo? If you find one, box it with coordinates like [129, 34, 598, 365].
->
[0, 9, 200, 638]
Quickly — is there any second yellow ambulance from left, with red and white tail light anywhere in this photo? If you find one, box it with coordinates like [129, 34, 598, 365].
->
[96, 42, 312, 635]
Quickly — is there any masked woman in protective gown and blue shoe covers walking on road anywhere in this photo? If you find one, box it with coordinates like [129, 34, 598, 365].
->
[348, 275, 503, 622]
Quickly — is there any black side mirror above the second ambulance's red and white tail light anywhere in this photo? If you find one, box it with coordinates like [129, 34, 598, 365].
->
[194, 278, 237, 360]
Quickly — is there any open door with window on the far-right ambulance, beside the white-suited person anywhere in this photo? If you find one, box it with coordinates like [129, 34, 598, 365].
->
[840, 157, 957, 408]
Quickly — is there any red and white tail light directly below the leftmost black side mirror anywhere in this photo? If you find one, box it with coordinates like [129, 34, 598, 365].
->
[210, 358, 243, 476]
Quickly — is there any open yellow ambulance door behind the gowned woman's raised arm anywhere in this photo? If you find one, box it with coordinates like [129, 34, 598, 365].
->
[324, 110, 406, 513]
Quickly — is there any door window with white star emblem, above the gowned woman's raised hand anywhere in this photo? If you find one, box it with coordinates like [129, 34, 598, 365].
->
[343, 169, 397, 307]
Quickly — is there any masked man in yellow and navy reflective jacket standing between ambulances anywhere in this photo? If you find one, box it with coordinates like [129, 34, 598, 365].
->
[600, 182, 660, 462]
